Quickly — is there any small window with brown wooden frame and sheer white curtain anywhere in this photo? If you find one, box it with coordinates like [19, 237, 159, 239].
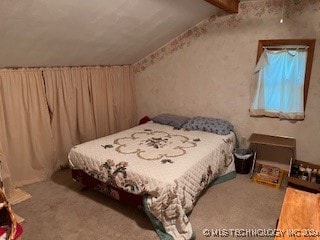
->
[250, 40, 315, 120]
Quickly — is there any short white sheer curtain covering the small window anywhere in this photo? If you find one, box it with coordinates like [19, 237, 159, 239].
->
[250, 49, 307, 119]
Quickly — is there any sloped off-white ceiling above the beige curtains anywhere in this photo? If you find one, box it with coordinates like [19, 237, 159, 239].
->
[0, 0, 219, 68]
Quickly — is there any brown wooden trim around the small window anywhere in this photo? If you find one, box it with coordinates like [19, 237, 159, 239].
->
[256, 39, 316, 111]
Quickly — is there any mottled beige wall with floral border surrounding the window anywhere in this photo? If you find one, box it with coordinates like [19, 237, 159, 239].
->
[135, 0, 320, 163]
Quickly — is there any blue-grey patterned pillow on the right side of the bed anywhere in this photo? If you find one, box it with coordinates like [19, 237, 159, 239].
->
[182, 117, 233, 135]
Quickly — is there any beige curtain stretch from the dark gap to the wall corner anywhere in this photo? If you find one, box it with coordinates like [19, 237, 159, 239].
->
[43, 66, 136, 165]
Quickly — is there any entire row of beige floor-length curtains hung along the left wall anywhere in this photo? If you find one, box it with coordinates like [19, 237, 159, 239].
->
[0, 66, 136, 189]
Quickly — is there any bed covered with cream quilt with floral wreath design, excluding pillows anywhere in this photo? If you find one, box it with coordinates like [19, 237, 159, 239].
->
[68, 121, 236, 239]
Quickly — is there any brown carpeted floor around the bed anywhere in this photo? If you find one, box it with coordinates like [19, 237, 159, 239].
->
[13, 170, 285, 240]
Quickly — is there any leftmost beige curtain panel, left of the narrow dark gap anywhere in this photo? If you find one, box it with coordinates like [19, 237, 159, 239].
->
[0, 69, 58, 189]
